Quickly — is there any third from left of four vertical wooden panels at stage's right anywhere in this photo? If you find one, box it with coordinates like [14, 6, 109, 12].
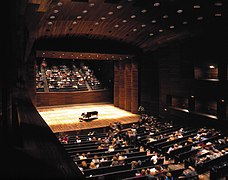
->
[124, 63, 131, 111]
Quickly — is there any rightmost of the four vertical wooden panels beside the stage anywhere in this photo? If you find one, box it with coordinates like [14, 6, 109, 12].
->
[131, 62, 138, 113]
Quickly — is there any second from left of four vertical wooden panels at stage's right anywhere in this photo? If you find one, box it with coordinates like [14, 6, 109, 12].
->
[119, 62, 125, 109]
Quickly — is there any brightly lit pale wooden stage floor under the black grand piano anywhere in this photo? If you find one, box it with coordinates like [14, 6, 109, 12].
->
[37, 102, 140, 133]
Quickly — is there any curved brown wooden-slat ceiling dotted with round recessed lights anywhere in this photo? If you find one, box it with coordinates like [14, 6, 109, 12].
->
[20, 0, 228, 58]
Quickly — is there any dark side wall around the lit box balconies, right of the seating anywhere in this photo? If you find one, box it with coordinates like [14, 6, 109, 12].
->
[152, 33, 228, 125]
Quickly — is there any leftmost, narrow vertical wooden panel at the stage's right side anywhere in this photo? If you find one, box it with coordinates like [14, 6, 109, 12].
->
[114, 62, 119, 107]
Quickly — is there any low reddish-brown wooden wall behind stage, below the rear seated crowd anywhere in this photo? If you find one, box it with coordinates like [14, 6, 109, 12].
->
[36, 90, 111, 106]
